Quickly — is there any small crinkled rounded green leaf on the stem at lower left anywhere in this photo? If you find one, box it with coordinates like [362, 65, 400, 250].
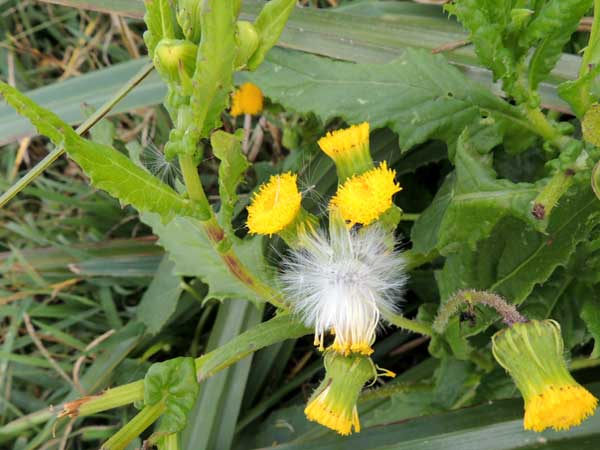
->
[144, 357, 198, 434]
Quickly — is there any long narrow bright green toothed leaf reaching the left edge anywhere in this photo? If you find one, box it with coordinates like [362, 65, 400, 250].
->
[0, 81, 195, 222]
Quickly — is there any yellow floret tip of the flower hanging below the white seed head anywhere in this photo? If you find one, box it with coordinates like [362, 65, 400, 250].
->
[304, 388, 360, 436]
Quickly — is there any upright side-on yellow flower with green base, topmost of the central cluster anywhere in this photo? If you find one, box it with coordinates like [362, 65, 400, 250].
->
[318, 122, 373, 182]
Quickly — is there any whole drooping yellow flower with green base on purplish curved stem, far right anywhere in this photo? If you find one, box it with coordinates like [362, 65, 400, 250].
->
[492, 320, 598, 432]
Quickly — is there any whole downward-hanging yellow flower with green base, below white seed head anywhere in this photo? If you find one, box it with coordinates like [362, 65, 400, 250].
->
[304, 351, 377, 435]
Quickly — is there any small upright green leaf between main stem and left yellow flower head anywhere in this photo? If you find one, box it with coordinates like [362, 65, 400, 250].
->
[210, 130, 250, 230]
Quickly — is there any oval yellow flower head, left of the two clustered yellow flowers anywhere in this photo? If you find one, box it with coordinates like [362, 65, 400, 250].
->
[247, 172, 302, 236]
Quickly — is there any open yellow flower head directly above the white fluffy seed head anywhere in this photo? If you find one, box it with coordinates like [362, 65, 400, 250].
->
[329, 161, 402, 225]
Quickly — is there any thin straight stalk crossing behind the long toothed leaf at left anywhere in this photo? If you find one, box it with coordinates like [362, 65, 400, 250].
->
[0, 63, 154, 208]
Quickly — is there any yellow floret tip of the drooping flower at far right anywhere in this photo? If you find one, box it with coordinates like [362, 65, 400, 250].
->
[523, 384, 598, 432]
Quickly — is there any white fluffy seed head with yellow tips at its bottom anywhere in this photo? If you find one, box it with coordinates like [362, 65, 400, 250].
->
[281, 225, 406, 354]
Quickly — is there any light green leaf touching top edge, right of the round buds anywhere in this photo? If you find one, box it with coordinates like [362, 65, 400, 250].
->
[248, 0, 296, 70]
